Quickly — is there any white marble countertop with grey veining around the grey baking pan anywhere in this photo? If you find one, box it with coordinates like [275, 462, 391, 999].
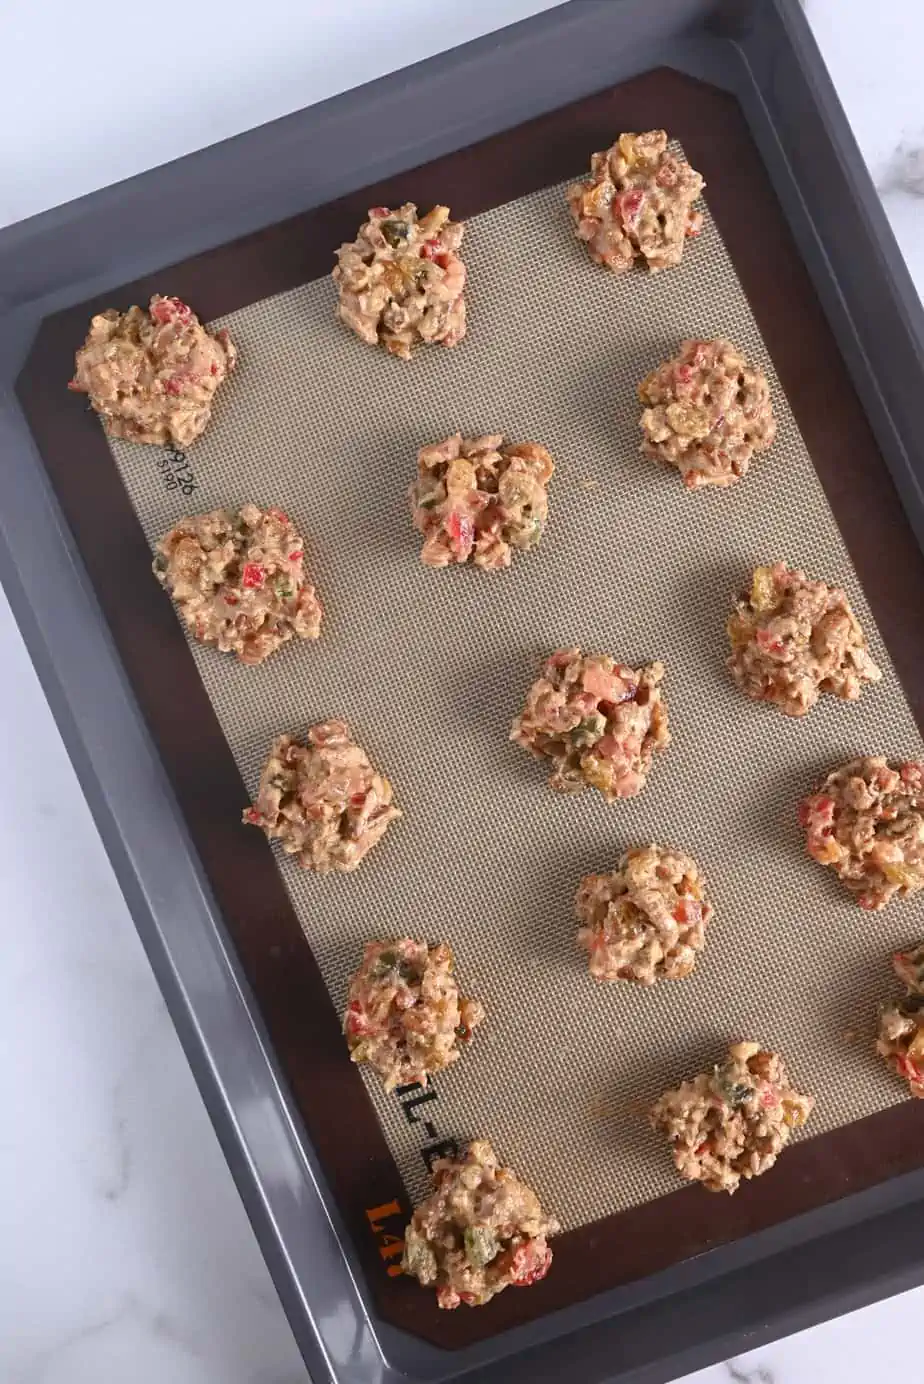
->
[0, 0, 924, 1384]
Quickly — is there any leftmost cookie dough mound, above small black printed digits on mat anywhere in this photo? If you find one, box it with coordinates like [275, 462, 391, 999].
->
[68, 293, 237, 447]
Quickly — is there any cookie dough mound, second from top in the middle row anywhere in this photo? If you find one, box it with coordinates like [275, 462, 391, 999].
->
[411, 433, 555, 570]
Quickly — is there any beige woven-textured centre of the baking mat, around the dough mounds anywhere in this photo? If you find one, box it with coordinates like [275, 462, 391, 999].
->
[104, 167, 924, 1229]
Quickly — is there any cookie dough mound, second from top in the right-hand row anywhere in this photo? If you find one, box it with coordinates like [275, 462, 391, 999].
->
[639, 340, 776, 490]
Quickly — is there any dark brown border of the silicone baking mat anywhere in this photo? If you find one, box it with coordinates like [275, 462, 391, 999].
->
[17, 69, 924, 1348]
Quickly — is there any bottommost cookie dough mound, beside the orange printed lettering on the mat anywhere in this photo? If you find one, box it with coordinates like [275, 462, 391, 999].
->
[401, 1139, 559, 1308]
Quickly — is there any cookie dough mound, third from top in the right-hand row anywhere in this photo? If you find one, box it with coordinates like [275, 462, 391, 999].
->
[728, 562, 883, 716]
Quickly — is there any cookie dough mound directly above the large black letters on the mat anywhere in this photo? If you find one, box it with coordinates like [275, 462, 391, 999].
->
[343, 937, 484, 1091]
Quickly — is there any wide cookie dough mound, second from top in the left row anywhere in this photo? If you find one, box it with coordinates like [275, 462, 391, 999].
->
[154, 505, 321, 664]
